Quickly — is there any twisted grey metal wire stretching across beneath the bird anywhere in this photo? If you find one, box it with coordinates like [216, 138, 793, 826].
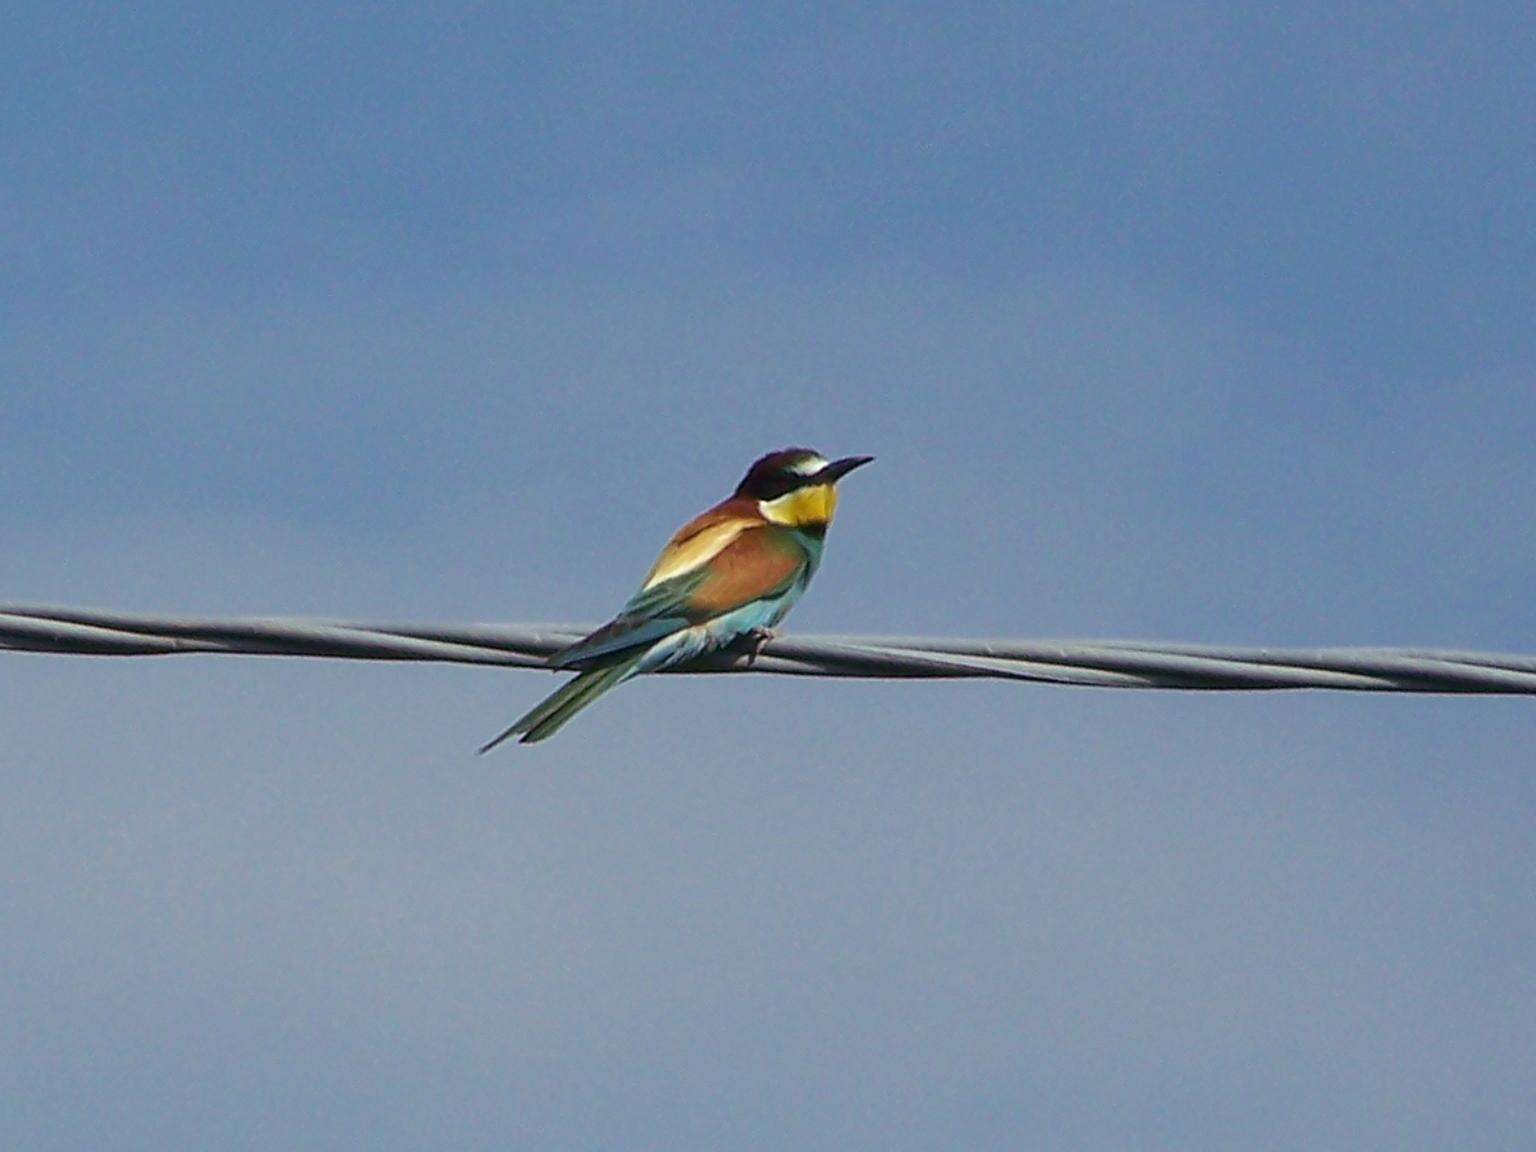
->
[0, 605, 1536, 696]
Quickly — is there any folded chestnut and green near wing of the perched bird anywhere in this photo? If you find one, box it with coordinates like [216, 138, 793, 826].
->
[550, 521, 809, 668]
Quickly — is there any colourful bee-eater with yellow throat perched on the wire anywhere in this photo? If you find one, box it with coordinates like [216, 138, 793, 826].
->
[479, 449, 874, 754]
